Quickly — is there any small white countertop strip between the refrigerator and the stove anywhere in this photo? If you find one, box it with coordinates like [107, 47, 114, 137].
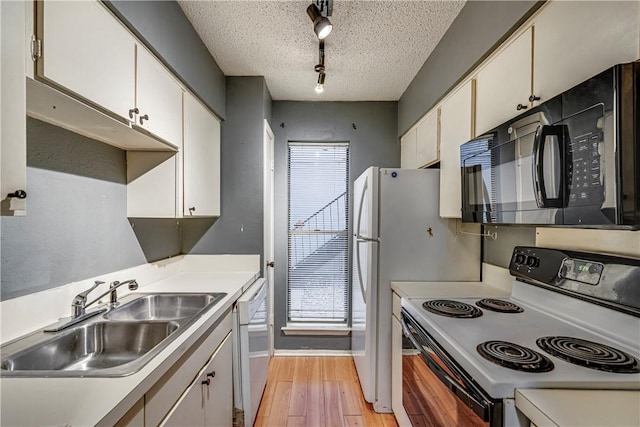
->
[391, 282, 510, 298]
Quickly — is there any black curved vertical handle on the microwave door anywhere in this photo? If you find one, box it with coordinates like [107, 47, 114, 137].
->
[533, 125, 569, 208]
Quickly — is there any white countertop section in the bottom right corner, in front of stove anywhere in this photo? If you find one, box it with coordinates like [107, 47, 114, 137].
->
[516, 389, 640, 427]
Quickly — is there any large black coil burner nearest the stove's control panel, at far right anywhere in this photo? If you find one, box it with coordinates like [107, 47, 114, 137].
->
[536, 337, 640, 374]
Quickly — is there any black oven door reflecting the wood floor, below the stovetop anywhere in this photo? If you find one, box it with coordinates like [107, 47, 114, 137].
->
[401, 309, 503, 427]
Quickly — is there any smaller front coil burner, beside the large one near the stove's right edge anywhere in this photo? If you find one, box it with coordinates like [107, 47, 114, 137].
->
[476, 341, 553, 372]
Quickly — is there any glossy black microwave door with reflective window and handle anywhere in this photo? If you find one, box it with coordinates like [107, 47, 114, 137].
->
[460, 118, 567, 224]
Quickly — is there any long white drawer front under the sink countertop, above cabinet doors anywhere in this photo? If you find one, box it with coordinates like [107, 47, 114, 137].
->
[144, 313, 231, 426]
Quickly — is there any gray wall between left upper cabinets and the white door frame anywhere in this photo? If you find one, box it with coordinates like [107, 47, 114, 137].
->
[183, 77, 272, 265]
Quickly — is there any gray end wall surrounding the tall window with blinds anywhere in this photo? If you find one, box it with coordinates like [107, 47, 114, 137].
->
[272, 101, 400, 350]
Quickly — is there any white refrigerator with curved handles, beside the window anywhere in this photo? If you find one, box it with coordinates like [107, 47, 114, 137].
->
[351, 167, 481, 412]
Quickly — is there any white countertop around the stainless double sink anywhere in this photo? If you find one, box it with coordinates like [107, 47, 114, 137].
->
[0, 270, 259, 426]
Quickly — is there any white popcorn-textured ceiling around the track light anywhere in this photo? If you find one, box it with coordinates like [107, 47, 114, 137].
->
[178, 0, 464, 101]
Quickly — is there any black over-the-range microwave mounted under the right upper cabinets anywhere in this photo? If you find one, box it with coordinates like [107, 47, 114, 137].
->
[460, 61, 640, 229]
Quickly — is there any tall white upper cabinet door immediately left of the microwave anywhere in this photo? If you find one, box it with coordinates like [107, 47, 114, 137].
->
[440, 81, 473, 218]
